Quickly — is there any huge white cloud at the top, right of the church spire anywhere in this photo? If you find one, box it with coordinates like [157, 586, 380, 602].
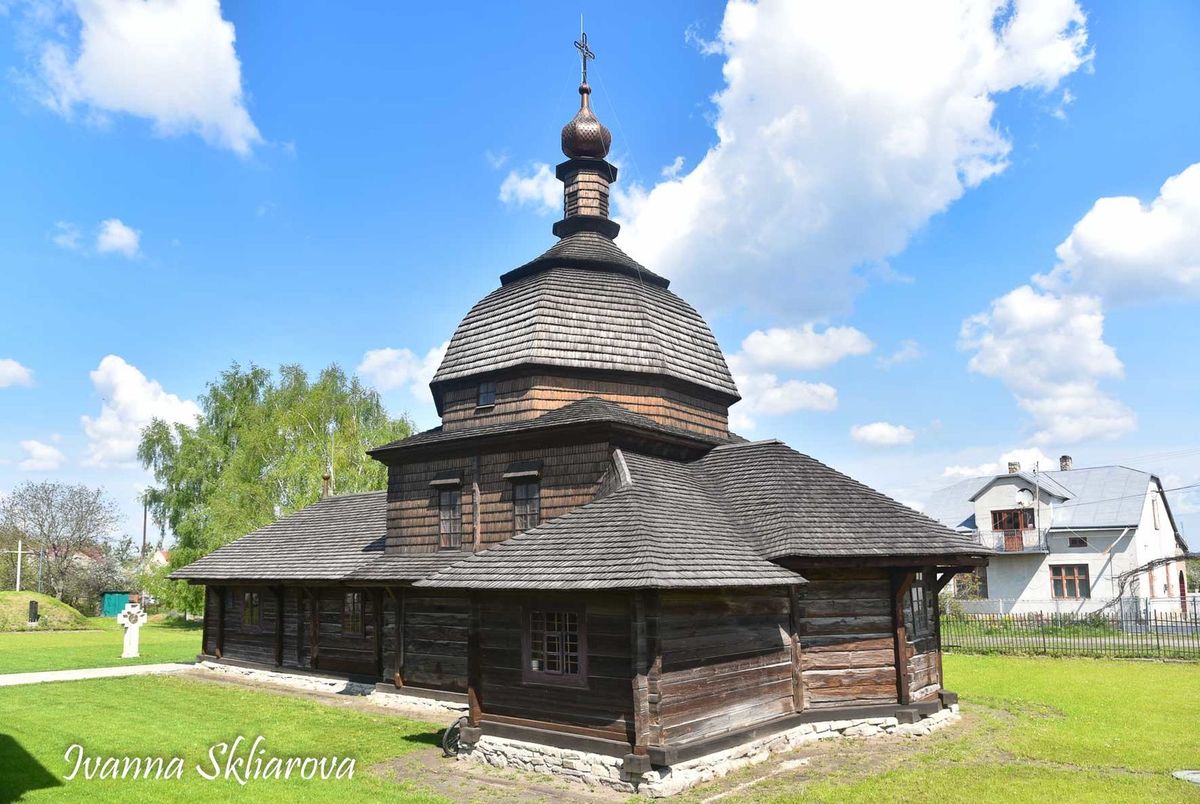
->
[614, 0, 1090, 318]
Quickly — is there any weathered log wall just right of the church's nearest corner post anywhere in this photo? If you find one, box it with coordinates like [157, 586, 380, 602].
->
[652, 587, 794, 742]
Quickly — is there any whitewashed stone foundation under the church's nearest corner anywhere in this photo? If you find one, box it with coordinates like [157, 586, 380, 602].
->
[458, 703, 960, 798]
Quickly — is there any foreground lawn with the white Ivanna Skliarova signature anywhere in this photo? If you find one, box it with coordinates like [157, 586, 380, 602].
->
[0, 676, 439, 802]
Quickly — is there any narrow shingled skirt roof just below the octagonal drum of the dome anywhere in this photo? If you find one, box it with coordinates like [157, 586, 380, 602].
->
[371, 396, 724, 455]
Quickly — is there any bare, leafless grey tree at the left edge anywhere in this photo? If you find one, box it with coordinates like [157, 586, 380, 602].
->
[0, 480, 120, 604]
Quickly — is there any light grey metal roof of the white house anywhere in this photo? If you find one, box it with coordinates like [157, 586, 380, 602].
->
[925, 466, 1154, 530]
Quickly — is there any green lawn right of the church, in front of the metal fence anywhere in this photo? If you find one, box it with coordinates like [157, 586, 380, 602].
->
[696, 656, 1200, 804]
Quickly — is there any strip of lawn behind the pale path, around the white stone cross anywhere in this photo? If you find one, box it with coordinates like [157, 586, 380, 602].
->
[0, 617, 200, 673]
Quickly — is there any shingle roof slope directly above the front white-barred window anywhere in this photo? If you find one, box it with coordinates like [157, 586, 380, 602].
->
[415, 452, 804, 589]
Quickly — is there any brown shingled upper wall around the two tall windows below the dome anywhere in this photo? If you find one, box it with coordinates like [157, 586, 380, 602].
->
[388, 443, 610, 552]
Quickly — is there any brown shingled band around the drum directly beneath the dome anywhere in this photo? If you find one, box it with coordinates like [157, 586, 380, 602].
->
[442, 373, 728, 437]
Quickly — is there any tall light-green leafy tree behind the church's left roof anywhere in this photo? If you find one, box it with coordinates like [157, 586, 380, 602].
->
[138, 364, 412, 612]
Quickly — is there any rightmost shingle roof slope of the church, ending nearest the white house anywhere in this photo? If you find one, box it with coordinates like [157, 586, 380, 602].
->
[698, 440, 988, 558]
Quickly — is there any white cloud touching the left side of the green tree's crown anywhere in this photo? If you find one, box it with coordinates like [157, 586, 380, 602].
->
[80, 354, 200, 467]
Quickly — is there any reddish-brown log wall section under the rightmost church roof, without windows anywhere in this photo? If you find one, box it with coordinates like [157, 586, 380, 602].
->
[797, 565, 898, 709]
